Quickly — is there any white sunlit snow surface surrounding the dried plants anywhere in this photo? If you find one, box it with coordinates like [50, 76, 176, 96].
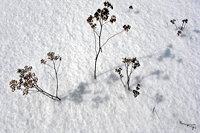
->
[0, 0, 200, 133]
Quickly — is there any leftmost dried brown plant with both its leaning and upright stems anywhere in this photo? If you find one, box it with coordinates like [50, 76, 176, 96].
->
[10, 52, 61, 101]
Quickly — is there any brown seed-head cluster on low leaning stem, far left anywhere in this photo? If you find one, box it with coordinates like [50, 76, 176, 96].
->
[10, 66, 61, 100]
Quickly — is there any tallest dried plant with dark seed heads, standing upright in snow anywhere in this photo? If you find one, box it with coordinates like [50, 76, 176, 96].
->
[87, 1, 131, 79]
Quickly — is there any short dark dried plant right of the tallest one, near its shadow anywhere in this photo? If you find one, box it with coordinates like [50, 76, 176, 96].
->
[115, 58, 140, 97]
